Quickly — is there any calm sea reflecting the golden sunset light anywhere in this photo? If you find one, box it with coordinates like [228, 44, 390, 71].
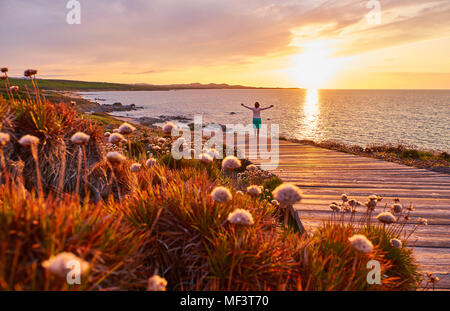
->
[80, 89, 450, 152]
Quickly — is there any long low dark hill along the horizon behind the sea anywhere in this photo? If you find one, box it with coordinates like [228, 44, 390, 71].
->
[10, 78, 296, 92]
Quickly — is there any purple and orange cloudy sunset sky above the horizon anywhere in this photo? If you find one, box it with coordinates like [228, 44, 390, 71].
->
[0, 0, 450, 89]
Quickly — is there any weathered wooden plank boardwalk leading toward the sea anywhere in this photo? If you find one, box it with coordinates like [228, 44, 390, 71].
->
[243, 141, 450, 289]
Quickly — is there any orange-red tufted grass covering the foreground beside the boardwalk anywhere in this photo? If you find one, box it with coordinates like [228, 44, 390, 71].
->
[0, 70, 426, 290]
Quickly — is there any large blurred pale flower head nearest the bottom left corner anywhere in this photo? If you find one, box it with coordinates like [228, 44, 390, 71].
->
[42, 252, 90, 277]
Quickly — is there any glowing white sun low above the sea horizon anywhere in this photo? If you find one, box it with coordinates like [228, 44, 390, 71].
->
[289, 42, 345, 89]
